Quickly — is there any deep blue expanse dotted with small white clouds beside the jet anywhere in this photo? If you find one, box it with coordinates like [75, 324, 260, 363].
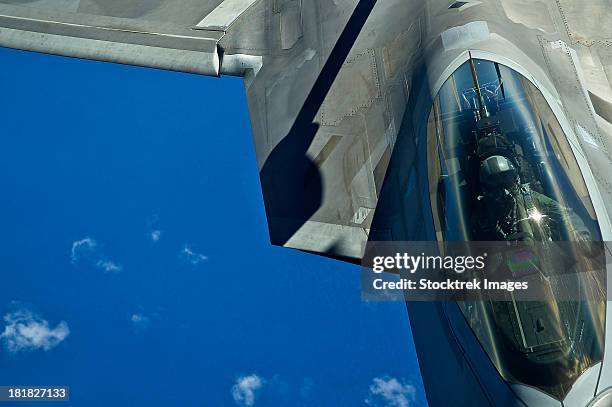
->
[0, 49, 425, 407]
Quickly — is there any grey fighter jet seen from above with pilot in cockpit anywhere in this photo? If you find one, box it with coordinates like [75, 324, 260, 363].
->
[0, 0, 612, 407]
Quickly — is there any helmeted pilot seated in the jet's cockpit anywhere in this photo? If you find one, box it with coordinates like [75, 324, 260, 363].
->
[476, 155, 592, 242]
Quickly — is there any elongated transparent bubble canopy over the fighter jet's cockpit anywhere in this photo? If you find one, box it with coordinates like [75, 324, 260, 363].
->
[427, 59, 605, 400]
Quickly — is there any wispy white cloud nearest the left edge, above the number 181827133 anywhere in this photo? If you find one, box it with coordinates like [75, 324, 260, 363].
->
[0, 309, 70, 353]
